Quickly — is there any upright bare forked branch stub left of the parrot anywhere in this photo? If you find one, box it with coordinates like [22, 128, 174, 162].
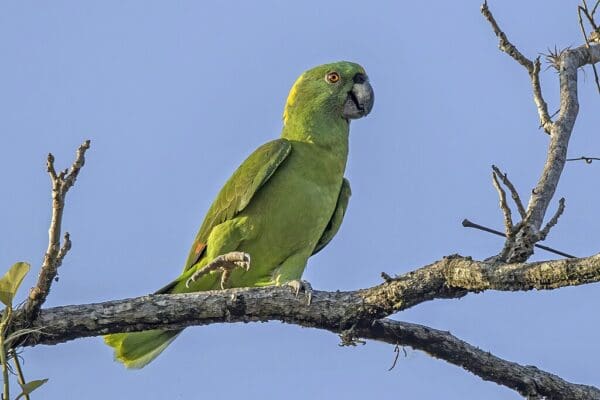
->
[25, 140, 90, 320]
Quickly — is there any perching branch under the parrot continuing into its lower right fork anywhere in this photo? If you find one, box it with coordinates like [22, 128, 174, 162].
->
[11, 280, 600, 399]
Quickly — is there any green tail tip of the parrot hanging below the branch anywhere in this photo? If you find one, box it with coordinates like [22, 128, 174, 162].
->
[104, 329, 181, 368]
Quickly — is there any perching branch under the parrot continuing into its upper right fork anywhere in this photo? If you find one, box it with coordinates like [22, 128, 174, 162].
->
[15, 254, 600, 345]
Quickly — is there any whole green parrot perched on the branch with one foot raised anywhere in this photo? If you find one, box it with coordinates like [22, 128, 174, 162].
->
[104, 61, 374, 368]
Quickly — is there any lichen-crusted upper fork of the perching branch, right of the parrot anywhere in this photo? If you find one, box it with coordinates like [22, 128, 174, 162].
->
[358, 254, 600, 318]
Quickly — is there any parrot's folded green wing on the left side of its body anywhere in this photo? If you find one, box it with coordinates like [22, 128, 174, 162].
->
[184, 139, 292, 271]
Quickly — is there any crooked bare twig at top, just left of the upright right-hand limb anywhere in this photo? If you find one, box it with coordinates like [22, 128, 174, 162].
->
[481, 1, 553, 134]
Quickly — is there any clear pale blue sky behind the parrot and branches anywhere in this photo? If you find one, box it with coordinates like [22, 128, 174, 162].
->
[0, 0, 600, 400]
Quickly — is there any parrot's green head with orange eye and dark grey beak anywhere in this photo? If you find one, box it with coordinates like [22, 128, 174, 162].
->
[283, 61, 375, 123]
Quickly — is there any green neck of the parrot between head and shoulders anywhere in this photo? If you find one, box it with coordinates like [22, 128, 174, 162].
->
[281, 115, 350, 152]
